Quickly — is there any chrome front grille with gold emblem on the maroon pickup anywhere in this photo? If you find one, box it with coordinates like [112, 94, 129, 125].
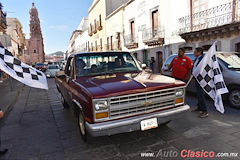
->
[109, 89, 175, 119]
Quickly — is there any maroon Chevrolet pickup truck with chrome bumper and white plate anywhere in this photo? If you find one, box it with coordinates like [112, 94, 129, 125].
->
[55, 52, 190, 141]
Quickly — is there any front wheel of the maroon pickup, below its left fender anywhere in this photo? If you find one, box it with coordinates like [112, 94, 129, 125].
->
[78, 111, 92, 142]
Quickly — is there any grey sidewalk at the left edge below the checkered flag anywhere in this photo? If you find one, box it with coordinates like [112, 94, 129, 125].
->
[0, 77, 23, 123]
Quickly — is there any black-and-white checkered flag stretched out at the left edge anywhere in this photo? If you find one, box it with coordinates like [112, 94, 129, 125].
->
[0, 47, 48, 89]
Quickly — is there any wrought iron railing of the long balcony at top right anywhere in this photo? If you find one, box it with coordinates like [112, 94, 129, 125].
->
[178, 0, 240, 34]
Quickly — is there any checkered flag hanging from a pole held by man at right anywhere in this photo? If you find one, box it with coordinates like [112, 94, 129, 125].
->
[193, 42, 228, 113]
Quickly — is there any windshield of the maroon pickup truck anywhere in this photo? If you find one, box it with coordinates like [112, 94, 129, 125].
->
[75, 52, 140, 76]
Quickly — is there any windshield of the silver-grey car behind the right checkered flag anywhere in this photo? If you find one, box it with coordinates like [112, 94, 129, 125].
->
[217, 53, 240, 70]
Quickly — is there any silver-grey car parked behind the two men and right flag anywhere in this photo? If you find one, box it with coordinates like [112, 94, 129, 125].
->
[162, 52, 240, 109]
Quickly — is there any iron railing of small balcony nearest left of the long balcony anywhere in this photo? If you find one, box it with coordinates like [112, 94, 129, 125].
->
[142, 26, 165, 42]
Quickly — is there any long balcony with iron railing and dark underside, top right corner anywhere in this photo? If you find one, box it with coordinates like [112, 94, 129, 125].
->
[178, 0, 240, 41]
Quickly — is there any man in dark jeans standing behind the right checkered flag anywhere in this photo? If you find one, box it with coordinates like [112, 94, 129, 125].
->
[192, 47, 208, 118]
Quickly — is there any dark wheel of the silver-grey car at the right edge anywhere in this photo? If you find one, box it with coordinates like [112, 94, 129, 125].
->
[228, 86, 240, 109]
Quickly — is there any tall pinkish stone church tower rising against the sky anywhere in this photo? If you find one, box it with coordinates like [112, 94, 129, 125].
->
[26, 3, 45, 64]
